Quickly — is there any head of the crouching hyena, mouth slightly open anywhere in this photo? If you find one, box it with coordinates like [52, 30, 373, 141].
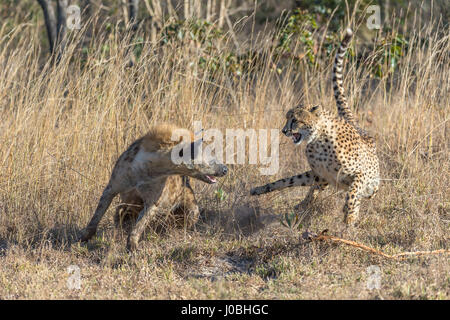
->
[171, 139, 228, 184]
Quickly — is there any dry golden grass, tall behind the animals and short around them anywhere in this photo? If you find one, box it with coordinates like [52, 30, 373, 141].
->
[0, 10, 450, 299]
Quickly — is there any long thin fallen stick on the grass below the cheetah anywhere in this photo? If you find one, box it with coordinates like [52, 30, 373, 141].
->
[302, 229, 450, 260]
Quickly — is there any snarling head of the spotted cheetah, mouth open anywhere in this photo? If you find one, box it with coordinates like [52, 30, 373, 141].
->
[282, 105, 322, 145]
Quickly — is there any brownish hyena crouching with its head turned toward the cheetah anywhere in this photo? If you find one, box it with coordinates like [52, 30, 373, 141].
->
[79, 124, 228, 251]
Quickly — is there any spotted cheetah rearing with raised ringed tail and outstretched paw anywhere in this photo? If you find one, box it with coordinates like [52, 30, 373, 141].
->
[250, 29, 380, 225]
